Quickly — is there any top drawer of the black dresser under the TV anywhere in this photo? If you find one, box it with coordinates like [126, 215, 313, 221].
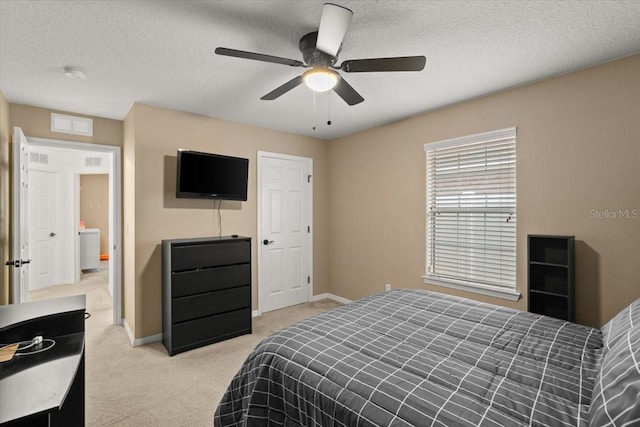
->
[171, 240, 251, 271]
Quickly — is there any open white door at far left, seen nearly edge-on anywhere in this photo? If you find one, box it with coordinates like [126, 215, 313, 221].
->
[11, 127, 31, 304]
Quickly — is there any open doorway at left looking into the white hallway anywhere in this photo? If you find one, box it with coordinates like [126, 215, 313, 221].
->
[28, 172, 113, 318]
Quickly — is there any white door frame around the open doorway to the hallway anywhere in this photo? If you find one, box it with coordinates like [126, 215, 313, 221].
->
[20, 136, 122, 325]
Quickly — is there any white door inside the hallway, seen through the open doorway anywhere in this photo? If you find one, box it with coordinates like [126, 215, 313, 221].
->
[29, 169, 60, 290]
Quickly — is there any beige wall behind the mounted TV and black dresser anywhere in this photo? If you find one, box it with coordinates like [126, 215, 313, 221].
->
[124, 104, 329, 338]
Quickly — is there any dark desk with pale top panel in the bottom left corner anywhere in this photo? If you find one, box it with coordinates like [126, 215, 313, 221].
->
[0, 295, 86, 427]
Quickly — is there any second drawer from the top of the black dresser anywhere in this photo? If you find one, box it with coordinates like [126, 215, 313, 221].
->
[171, 264, 251, 298]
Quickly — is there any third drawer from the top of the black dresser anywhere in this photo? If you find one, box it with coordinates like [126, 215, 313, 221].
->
[171, 285, 251, 323]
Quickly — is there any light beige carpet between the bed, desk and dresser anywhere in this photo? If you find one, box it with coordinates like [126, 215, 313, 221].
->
[30, 266, 339, 427]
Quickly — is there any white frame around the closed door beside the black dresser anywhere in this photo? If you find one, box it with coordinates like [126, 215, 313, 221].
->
[253, 151, 314, 316]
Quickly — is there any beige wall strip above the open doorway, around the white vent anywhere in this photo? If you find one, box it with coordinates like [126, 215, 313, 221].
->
[11, 104, 123, 147]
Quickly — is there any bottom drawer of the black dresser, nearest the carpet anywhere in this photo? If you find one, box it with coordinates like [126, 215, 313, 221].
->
[172, 308, 251, 351]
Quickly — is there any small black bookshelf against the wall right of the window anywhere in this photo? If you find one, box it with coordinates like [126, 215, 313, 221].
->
[527, 234, 575, 322]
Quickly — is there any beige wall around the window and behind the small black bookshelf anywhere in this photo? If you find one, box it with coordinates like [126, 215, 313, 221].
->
[328, 55, 640, 326]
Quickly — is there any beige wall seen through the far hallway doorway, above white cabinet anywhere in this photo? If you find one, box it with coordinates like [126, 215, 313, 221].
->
[80, 174, 109, 254]
